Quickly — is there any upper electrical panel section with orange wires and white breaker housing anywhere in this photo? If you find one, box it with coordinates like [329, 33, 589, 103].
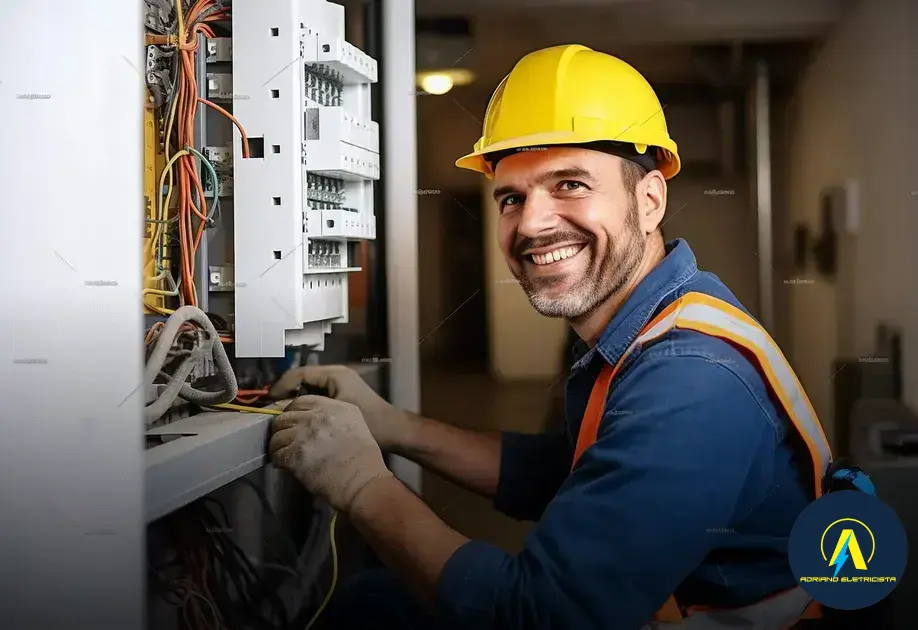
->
[144, 0, 380, 359]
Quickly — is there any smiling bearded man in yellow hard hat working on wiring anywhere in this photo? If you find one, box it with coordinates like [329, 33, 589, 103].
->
[270, 46, 830, 630]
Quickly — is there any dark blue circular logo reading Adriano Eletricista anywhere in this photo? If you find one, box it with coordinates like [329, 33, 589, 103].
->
[787, 490, 908, 610]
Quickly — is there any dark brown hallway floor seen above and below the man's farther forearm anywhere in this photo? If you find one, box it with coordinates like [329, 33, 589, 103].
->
[421, 365, 563, 551]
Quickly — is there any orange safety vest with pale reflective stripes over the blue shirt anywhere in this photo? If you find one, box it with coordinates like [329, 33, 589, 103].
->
[572, 292, 832, 628]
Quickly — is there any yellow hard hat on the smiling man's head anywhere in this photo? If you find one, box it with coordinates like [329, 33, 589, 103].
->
[456, 45, 680, 179]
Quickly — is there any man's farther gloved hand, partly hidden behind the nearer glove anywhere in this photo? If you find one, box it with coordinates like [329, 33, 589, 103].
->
[268, 365, 412, 450]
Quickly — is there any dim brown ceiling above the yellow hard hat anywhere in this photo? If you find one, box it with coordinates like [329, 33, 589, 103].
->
[416, 0, 847, 91]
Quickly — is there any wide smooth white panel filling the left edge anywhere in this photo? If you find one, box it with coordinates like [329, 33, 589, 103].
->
[0, 0, 146, 630]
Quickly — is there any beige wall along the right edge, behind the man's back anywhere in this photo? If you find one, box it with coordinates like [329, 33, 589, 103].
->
[782, 0, 918, 444]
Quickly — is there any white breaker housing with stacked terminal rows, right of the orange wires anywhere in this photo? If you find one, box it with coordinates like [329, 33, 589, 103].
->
[203, 0, 380, 357]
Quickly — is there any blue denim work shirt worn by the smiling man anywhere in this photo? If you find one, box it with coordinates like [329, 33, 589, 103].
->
[437, 240, 811, 630]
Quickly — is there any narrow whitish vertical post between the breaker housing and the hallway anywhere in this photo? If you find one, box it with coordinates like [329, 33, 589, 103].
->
[380, 0, 421, 493]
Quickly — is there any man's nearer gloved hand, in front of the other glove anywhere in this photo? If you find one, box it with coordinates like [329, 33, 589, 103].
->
[268, 396, 392, 513]
